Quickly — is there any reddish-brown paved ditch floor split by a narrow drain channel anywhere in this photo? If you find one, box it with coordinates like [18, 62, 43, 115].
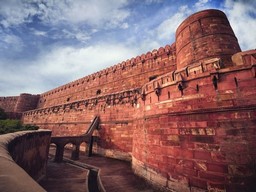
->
[40, 150, 157, 192]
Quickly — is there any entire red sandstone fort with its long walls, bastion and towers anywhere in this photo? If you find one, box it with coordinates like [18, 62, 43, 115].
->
[0, 10, 256, 192]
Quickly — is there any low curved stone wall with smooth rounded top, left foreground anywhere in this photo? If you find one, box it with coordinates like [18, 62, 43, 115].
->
[0, 130, 51, 192]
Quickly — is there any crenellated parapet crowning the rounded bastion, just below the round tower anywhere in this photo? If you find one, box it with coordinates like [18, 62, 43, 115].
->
[141, 50, 256, 100]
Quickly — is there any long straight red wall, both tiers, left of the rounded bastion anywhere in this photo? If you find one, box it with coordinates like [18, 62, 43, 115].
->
[23, 45, 176, 159]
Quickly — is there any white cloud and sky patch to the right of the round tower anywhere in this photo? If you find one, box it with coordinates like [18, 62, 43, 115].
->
[224, 0, 256, 50]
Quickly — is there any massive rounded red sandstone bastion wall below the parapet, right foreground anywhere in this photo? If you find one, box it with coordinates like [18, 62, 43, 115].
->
[132, 59, 256, 192]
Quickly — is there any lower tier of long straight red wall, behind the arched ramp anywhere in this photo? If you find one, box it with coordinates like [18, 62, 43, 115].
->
[23, 89, 140, 159]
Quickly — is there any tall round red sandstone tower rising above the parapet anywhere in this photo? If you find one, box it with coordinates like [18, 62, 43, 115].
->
[176, 9, 241, 70]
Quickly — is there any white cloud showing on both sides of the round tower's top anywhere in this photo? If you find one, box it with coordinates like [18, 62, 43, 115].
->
[154, 0, 256, 50]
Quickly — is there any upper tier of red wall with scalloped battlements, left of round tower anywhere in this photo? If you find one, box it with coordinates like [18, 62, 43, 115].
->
[38, 45, 176, 108]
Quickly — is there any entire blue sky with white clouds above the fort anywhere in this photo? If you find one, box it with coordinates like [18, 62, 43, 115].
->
[0, 0, 256, 96]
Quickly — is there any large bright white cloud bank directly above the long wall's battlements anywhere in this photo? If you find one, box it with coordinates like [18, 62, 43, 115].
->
[0, 42, 138, 96]
